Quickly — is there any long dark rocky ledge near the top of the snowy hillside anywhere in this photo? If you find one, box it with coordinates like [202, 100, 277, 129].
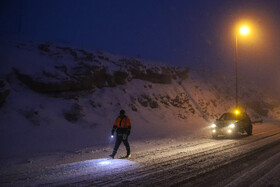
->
[14, 44, 189, 93]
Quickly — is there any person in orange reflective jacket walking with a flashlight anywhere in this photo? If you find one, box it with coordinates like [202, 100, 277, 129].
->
[109, 110, 131, 158]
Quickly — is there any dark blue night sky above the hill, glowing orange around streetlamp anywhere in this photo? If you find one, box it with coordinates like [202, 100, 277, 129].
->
[0, 0, 280, 72]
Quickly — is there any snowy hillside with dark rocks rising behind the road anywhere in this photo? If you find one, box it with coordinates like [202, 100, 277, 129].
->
[0, 42, 280, 157]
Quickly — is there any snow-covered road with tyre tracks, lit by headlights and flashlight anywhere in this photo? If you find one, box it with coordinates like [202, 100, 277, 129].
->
[0, 123, 280, 186]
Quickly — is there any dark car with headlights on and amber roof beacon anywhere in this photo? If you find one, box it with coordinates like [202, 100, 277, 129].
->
[211, 111, 253, 138]
